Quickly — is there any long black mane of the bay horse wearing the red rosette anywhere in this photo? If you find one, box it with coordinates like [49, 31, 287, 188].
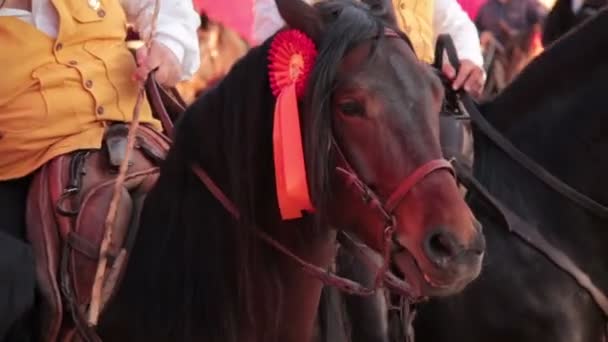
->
[102, 1, 392, 342]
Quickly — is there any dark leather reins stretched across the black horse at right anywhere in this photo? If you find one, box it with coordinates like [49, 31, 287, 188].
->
[436, 36, 608, 332]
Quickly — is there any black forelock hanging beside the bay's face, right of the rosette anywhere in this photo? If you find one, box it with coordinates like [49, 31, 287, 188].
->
[303, 0, 385, 228]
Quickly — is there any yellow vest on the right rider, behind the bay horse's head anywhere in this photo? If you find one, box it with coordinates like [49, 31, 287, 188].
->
[393, 0, 435, 63]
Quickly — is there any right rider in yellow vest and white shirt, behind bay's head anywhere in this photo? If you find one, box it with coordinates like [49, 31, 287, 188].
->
[253, 0, 485, 96]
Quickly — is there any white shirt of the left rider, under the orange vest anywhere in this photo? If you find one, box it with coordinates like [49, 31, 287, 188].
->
[0, 0, 200, 79]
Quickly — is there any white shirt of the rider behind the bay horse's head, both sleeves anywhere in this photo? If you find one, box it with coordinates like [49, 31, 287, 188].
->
[253, 0, 483, 67]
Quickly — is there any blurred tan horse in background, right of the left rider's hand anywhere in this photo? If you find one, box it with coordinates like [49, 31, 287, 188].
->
[176, 12, 249, 104]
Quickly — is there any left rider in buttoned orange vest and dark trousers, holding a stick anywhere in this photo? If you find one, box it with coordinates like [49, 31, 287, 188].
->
[0, 0, 200, 341]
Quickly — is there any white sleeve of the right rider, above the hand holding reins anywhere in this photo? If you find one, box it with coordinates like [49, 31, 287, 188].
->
[433, 0, 483, 67]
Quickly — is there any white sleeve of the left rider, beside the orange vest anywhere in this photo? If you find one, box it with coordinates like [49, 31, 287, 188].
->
[121, 0, 201, 80]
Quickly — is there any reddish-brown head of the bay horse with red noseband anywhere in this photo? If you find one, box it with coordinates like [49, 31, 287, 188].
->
[277, 0, 485, 296]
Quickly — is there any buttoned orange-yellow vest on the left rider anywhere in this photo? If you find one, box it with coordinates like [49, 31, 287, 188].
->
[0, 0, 160, 180]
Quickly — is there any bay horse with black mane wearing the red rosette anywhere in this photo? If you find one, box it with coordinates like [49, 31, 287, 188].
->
[91, 0, 484, 342]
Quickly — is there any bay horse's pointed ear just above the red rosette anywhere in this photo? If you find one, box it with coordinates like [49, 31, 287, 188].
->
[275, 0, 323, 42]
